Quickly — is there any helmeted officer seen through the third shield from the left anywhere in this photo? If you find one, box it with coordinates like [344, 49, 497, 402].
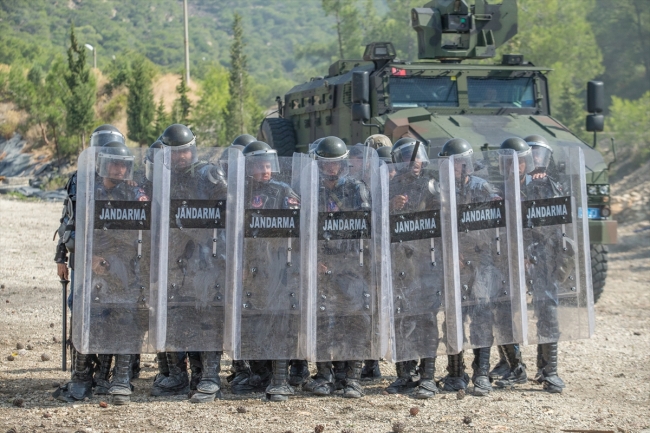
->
[239, 141, 300, 401]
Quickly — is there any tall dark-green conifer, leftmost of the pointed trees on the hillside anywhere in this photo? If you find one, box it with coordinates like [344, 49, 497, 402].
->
[64, 24, 96, 151]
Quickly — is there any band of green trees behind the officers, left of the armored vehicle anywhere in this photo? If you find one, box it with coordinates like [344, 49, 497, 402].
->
[0, 14, 263, 158]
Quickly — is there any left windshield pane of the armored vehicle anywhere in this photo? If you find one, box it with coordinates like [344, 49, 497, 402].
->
[388, 77, 458, 108]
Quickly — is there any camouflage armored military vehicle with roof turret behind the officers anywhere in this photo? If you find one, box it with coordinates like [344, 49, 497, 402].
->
[258, 0, 617, 299]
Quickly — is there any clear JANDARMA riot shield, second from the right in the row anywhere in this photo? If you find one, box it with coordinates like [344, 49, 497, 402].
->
[440, 151, 523, 351]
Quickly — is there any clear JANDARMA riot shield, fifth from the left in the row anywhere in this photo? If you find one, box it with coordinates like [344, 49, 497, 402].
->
[385, 162, 456, 362]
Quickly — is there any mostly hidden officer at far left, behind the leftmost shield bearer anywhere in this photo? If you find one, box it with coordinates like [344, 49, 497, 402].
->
[54, 124, 125, 401]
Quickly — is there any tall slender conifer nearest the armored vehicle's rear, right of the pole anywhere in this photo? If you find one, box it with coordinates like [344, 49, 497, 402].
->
[224, 13, 249, 140]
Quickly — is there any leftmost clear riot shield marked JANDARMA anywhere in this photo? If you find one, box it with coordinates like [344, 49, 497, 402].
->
[72, 147, 155, 354]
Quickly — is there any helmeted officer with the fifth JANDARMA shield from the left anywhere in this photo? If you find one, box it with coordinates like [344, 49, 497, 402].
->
[386, 138, 444, 399]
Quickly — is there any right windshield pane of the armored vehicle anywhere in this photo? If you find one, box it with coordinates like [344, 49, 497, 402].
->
[467, 77, 535, 108]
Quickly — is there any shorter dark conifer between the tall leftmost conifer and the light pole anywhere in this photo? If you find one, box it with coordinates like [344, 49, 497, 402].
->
[126, 57, 154, 144]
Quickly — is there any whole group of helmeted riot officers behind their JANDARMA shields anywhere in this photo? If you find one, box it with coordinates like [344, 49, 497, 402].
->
[55, 124, 593, 404]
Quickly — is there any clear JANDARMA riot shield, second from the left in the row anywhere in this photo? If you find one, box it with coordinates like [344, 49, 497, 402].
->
[152, 147, 232, 351]
